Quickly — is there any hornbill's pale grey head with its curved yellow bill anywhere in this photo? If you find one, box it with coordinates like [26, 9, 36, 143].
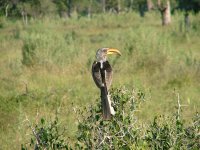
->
[96, 48, 121, 62]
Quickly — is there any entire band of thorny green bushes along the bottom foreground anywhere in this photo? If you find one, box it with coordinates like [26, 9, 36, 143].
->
[22, 88, 200, 150]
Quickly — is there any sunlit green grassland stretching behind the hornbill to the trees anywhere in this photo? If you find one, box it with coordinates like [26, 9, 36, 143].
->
[0, 13, 200, 149]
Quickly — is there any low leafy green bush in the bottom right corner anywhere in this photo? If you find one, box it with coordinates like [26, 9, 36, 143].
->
[145, 113, 200, 150]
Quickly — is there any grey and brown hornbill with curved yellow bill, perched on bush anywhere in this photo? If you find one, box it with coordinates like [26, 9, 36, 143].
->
[92, 48, 121, 120]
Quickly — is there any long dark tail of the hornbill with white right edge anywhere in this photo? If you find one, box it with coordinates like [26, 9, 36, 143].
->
[101, 87, 115, 120]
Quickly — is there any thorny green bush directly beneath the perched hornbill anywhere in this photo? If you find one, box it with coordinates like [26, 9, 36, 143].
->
[76, 88, 146, 149]
